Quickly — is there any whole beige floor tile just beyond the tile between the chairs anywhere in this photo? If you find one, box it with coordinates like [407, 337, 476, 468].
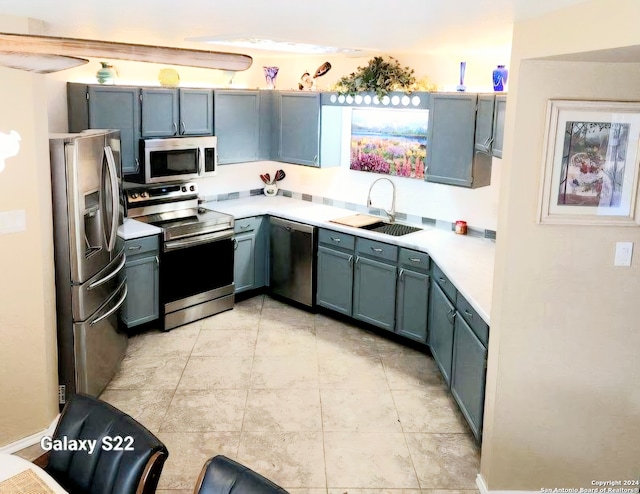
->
[160, 389, 247, 432]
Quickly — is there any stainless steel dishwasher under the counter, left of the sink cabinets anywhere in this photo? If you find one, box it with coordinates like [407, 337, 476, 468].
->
[269, 217, 316, 307]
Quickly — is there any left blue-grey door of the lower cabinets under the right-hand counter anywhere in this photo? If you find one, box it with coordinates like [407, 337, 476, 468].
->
[429, 282, 456, 385]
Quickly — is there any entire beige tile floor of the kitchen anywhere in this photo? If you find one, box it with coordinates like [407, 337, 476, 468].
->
[101, 295, 479, 494]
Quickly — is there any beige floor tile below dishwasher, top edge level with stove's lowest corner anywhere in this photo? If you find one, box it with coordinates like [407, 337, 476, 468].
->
[255, 322, 318, 356]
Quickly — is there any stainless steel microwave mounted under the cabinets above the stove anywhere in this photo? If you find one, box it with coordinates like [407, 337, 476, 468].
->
[135, 136, 218, 184]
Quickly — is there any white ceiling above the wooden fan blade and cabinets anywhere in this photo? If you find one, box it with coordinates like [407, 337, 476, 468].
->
[0, 0, 586, 56]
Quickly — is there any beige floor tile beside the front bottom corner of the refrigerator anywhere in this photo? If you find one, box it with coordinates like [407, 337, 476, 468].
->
[107, 356, 189, 389]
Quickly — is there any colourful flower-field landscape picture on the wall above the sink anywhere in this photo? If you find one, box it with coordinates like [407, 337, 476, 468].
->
[350, 108, 429, 180]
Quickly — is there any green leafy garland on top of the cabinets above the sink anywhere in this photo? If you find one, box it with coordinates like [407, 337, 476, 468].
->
[333, 57, 438, 98]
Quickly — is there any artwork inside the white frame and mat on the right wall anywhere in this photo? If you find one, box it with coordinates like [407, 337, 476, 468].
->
[558, 122, 631, 207]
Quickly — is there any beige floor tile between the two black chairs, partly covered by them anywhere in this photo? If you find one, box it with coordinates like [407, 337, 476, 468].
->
[158, 432, 240, 492]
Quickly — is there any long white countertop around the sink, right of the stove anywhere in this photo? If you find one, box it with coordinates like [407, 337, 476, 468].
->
[202, 196, 495, 324]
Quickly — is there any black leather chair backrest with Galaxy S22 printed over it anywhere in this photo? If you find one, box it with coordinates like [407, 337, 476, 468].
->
[45, 394, 169, 494]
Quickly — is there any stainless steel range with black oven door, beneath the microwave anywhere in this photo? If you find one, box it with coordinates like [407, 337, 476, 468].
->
[125, 182, 234, 331]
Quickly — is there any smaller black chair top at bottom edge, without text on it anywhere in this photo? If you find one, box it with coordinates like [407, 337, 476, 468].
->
[194, 455, 289, 494]
